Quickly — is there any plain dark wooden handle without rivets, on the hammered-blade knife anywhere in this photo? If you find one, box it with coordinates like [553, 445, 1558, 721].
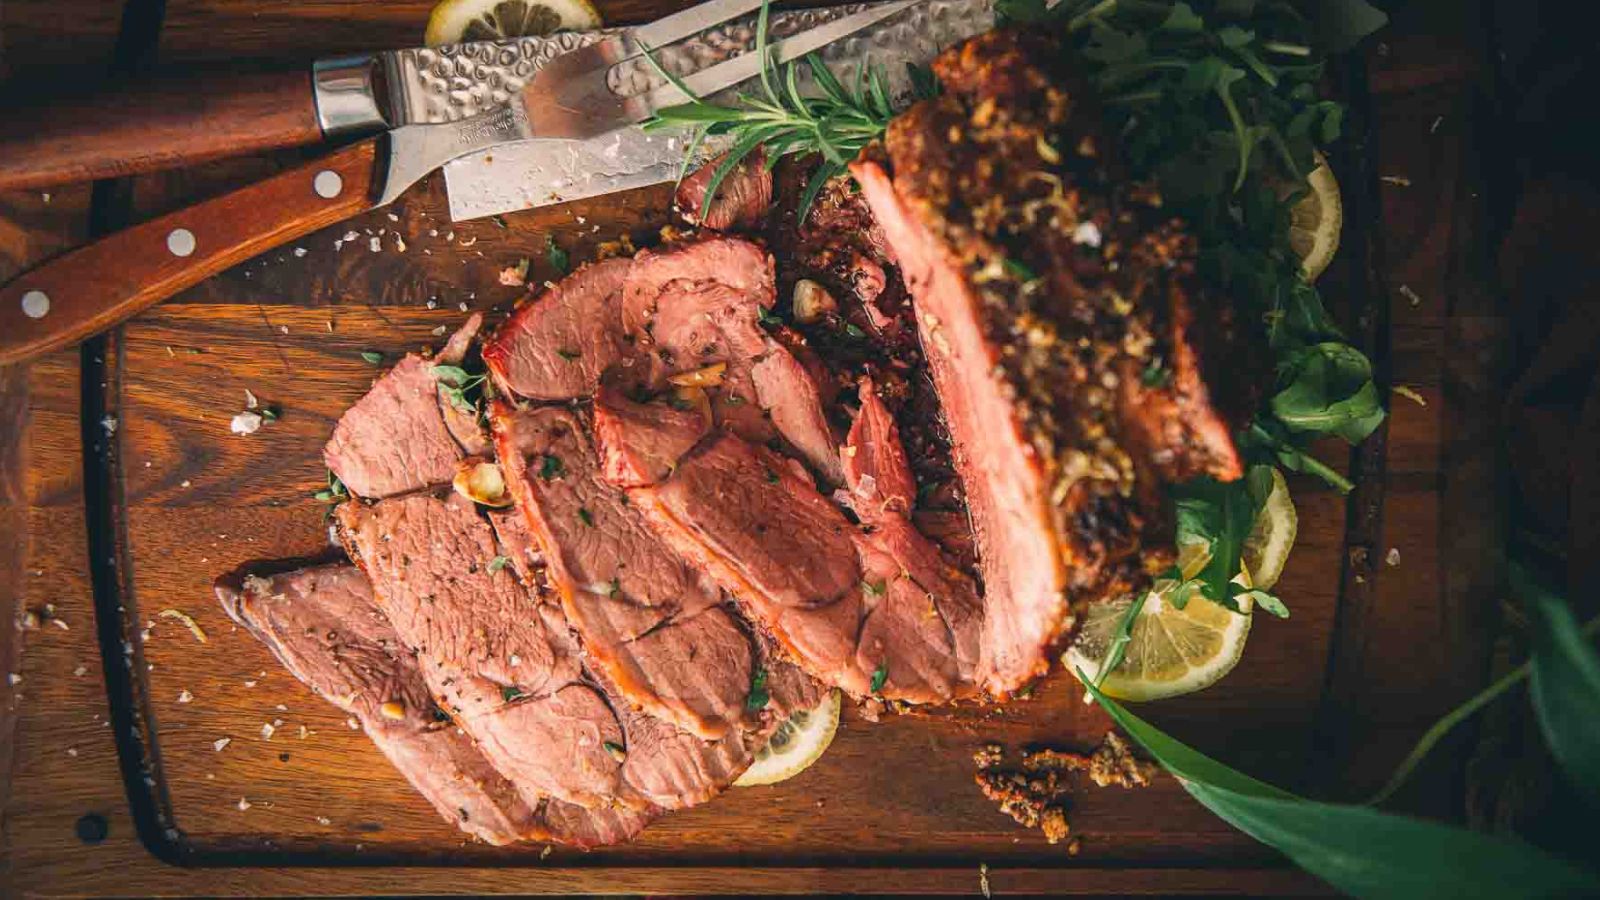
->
[0, 70, 322, 191]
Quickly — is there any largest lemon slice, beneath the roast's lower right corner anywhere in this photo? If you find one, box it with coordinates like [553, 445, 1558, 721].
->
[1062, 580, 1251, 700]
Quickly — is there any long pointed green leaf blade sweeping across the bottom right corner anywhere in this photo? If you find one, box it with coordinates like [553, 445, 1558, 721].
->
[1077, 669, 1600, 900]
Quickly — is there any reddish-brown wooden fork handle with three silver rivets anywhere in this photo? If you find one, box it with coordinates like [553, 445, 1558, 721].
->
[0, 138, 378, 367]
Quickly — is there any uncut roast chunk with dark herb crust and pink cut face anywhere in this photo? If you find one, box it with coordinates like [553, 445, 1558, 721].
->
[851, 30, 1248, 693]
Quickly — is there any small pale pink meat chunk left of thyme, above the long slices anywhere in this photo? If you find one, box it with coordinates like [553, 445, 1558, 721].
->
[322, 354, 464, 498]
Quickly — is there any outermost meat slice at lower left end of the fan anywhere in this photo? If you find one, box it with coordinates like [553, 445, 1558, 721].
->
[216, 562, 651, 847]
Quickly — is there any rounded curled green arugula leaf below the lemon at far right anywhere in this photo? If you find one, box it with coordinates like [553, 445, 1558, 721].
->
[1269, 341, 1384, 444]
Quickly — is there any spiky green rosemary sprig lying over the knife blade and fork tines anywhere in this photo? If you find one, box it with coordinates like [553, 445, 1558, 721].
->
[645, 3, 933, 218]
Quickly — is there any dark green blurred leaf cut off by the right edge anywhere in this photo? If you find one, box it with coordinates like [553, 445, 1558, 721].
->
[1510, 562, 1600, 801]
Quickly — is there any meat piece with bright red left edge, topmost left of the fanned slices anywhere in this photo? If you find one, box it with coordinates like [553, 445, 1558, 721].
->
[483, 259, 630, 400]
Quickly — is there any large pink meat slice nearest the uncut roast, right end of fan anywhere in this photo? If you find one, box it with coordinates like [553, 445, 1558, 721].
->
[629, 434, 979, 703]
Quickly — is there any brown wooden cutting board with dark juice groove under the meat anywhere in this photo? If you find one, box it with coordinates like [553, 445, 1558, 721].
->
[0, 3, 1482, 895]
